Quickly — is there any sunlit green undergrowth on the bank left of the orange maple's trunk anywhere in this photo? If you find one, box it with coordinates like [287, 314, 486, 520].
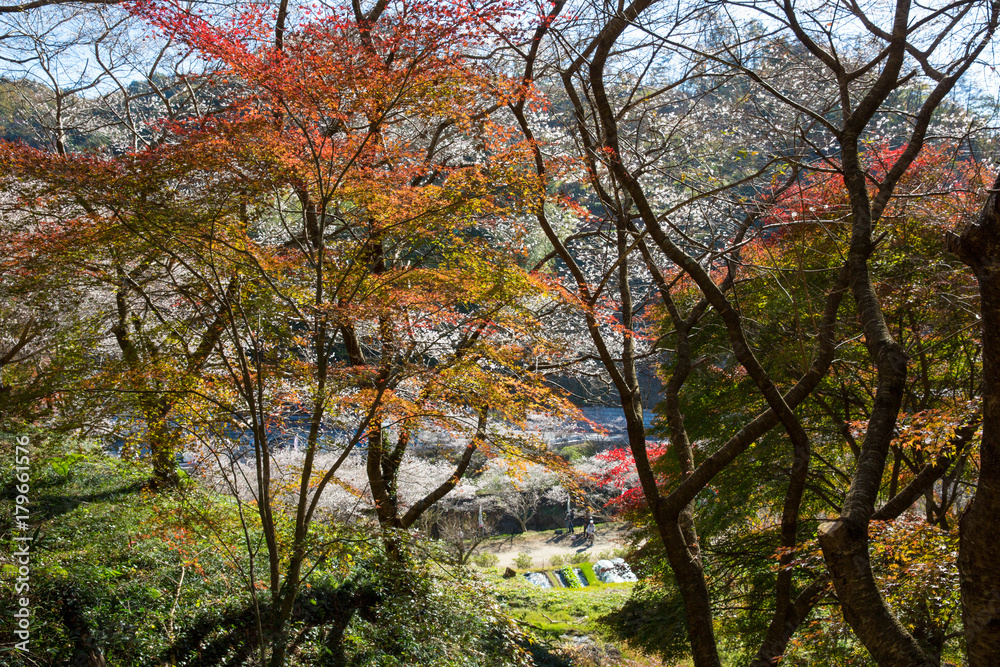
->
[0, 453, 266, 667]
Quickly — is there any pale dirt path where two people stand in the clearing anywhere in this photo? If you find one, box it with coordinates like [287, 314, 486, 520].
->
[477, 523, 625, 568]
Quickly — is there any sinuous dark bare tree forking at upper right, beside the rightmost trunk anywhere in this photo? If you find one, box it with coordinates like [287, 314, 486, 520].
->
[739, 2, 1000, 665]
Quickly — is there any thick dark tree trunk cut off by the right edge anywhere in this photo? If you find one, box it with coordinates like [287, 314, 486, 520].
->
[948, 176, 1000, 667]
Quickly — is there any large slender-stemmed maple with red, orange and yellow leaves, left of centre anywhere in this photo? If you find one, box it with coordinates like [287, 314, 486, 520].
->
[0, 4, 584, 665]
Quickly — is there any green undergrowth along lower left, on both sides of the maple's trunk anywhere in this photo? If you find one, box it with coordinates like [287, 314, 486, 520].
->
[0, 453, 600, 665]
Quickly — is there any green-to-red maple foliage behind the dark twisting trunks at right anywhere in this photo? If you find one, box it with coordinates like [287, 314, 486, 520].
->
[720, 144, 982, 660]
